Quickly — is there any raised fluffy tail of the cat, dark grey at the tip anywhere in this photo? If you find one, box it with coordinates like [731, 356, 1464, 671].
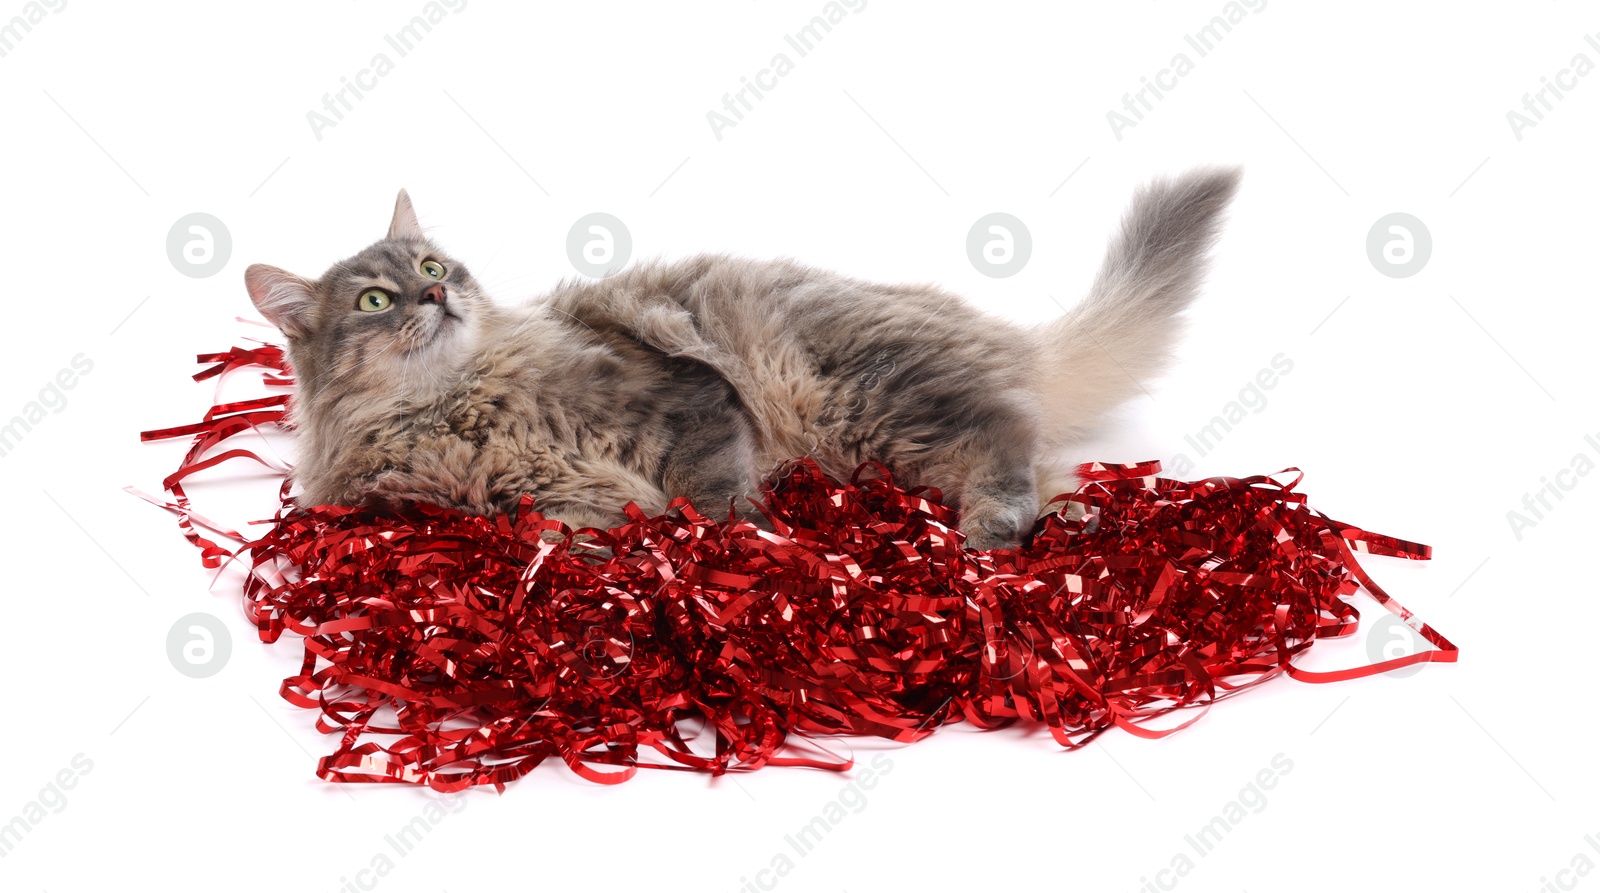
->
[1035, 168, 1240, 445]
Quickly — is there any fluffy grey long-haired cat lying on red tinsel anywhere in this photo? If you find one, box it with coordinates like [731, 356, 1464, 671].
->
[245, 168, 1240, 549]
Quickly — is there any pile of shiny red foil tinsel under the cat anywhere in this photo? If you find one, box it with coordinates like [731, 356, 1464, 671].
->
[134, 337, 1456, 791]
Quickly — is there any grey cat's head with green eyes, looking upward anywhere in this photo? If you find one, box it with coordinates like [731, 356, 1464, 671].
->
[245, 189, 491, 403]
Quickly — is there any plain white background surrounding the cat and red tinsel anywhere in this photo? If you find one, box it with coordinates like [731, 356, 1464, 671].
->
[0, 0, 1600, 891]
